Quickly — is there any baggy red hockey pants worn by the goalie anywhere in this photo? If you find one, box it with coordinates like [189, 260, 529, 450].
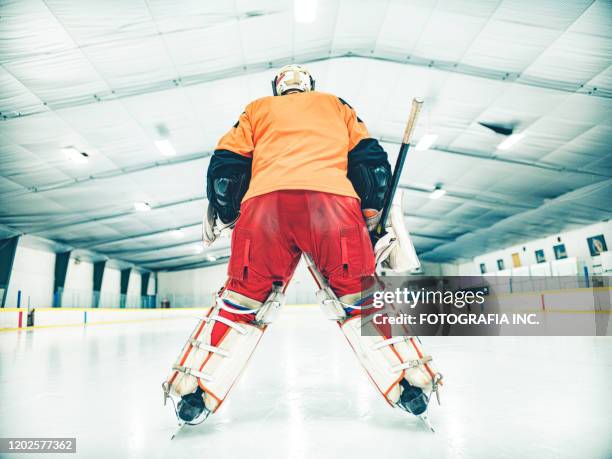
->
[213, 190, 374, 345]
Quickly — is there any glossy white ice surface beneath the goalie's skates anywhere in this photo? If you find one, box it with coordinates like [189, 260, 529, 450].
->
[0, 306, 612, 459]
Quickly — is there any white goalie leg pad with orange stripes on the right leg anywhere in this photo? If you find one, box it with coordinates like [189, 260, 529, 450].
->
[340, 316, 436, 405]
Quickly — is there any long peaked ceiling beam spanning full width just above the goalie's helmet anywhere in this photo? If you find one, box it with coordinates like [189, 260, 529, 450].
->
[9, 50, 610, 118]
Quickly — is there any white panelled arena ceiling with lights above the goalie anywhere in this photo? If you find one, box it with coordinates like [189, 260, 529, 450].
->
[0, 0, 612, 270]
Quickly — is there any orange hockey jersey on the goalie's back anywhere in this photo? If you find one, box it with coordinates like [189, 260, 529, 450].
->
[216, 91, 378, 202]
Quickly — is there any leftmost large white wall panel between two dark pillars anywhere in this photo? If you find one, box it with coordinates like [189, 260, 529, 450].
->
[5, 245, 55, 308]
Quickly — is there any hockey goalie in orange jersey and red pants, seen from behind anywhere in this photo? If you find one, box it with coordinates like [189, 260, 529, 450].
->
[163, 65, 440, 432]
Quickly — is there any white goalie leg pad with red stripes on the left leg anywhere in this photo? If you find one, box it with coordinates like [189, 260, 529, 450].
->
[166, 297, 265, 412]
